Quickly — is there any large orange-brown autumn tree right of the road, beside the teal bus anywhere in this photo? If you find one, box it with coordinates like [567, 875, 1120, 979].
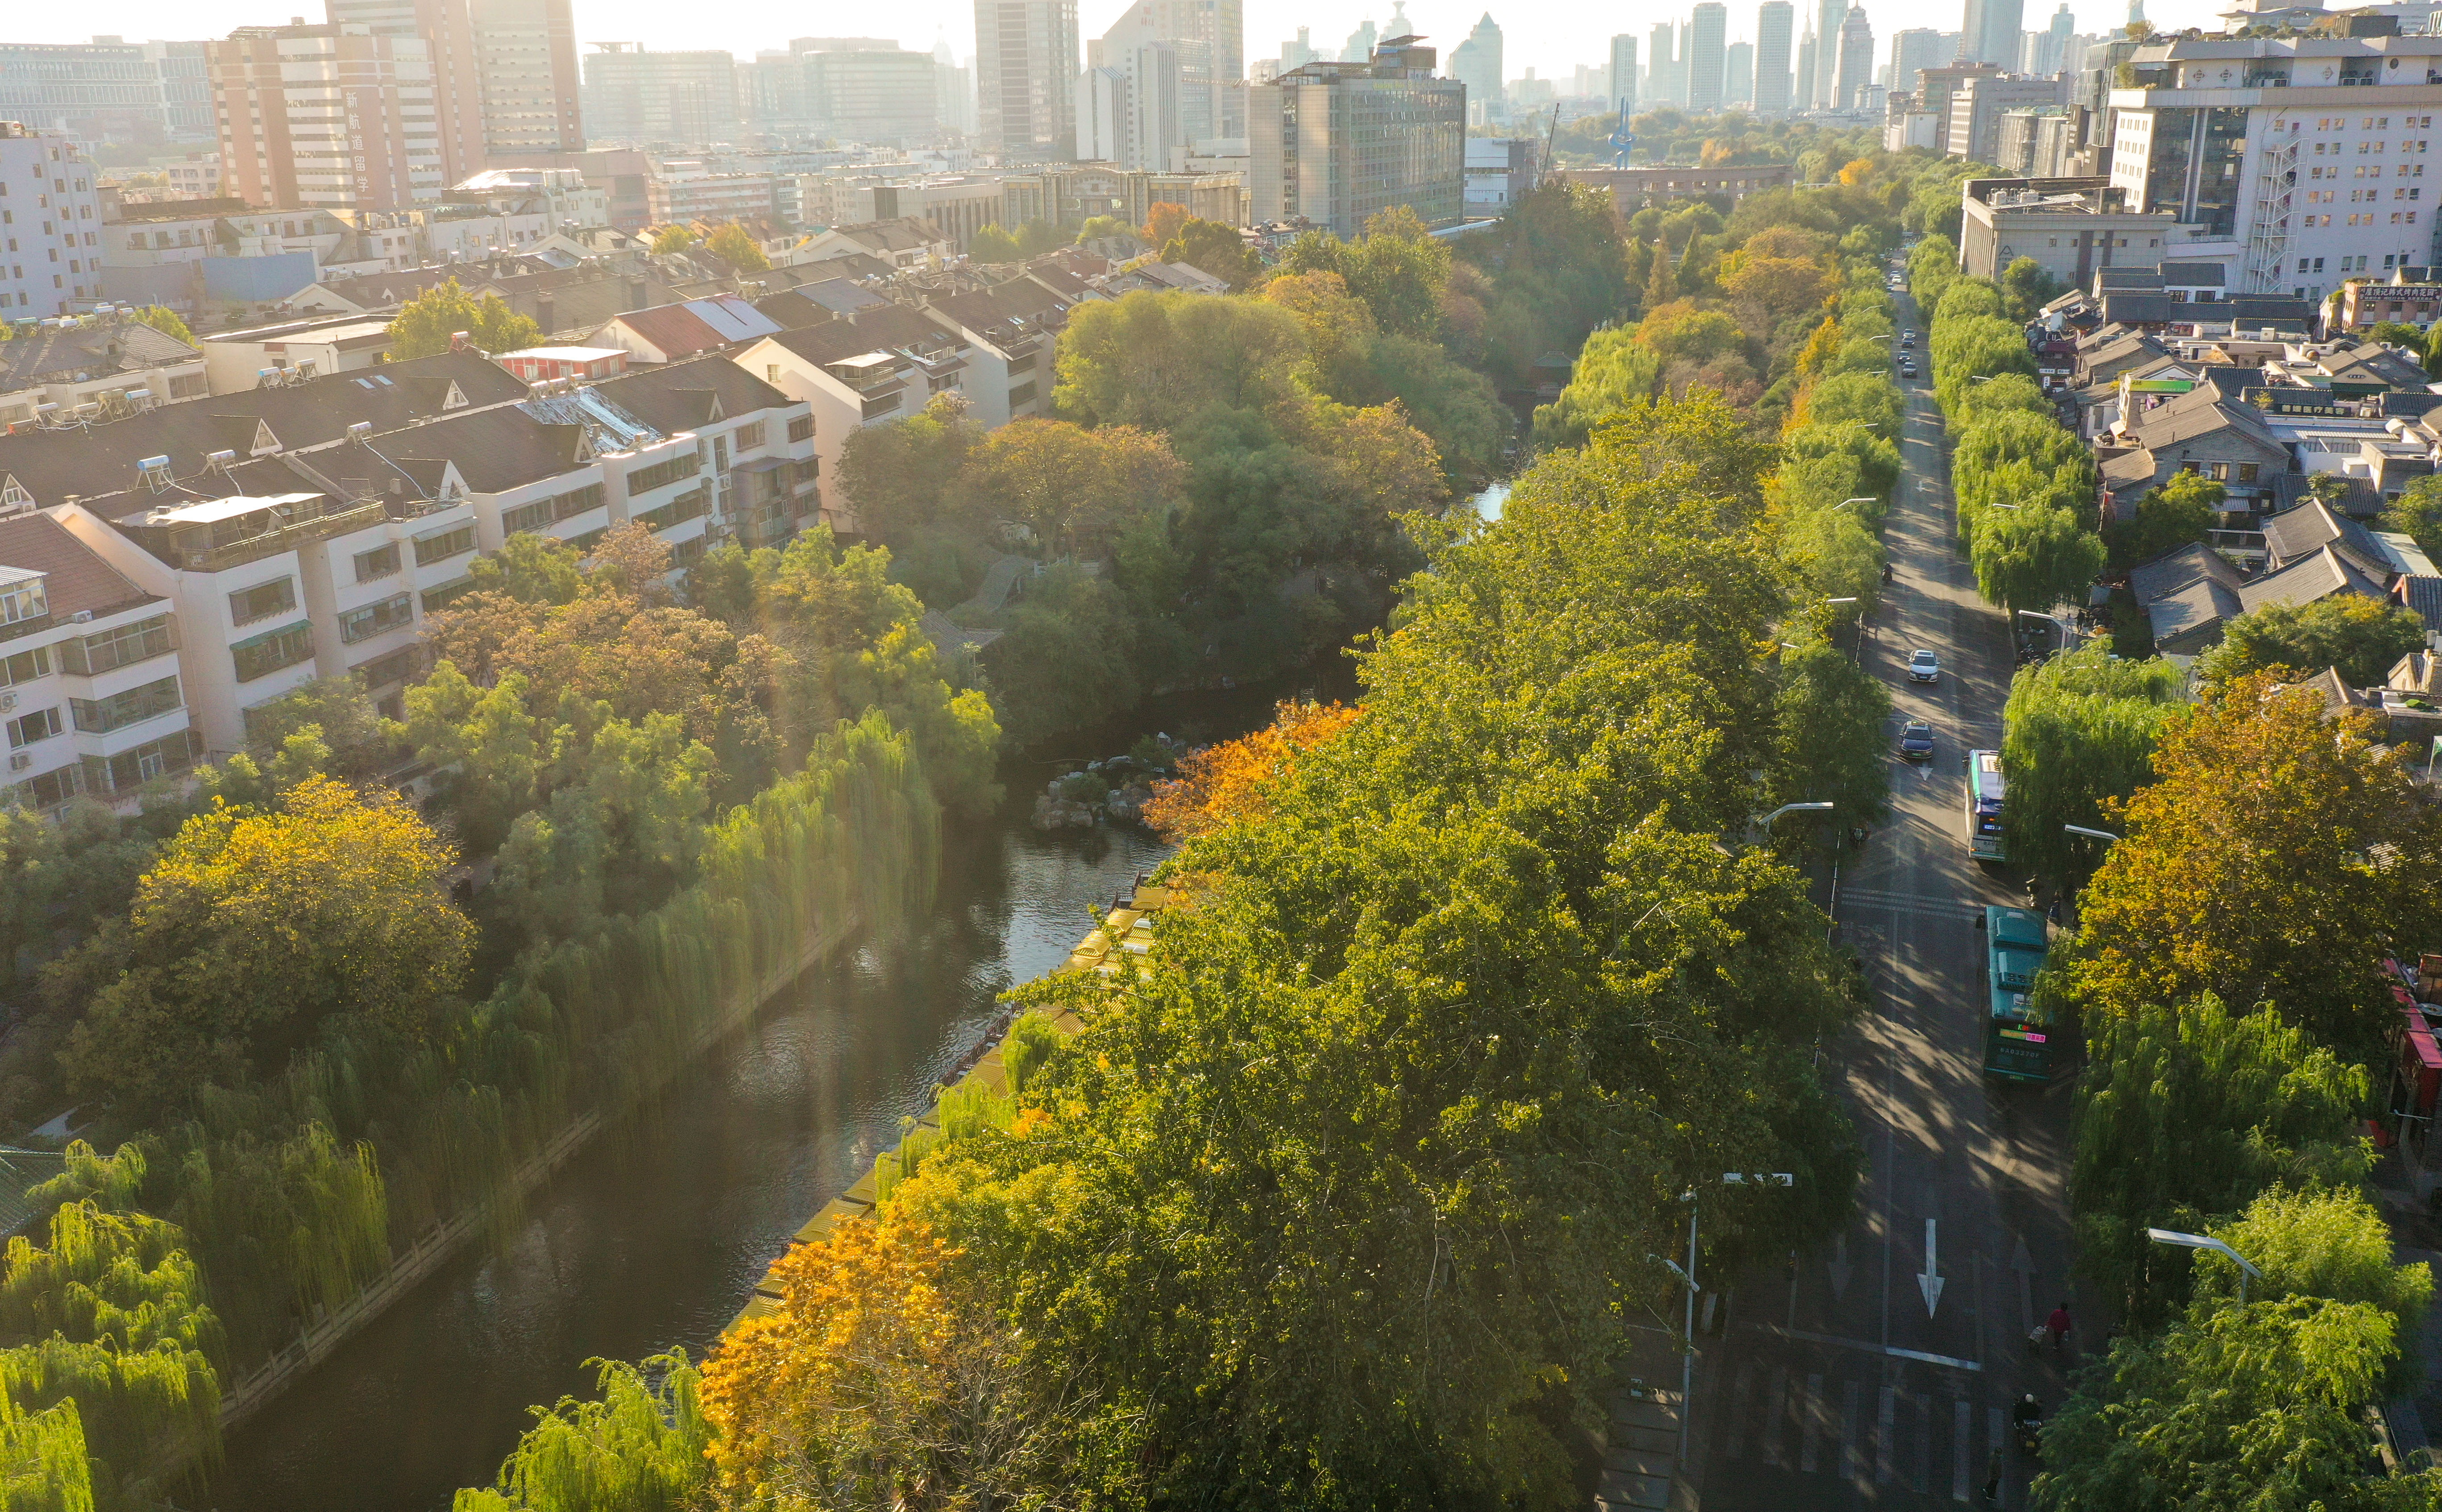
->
[2047, 674, 2442, 1058]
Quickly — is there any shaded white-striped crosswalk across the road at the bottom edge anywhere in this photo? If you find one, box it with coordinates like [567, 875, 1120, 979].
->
[1697, 1361, 2027, 1505]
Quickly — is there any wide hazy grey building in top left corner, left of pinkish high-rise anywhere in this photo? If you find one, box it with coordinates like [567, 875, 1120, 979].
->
[0, 37, 212, 146]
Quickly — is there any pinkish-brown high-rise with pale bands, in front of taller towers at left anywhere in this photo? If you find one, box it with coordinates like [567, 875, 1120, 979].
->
[205, 27, 444, 210]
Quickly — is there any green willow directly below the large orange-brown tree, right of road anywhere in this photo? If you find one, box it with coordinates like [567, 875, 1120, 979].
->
[2068, 994, 2369, 1329]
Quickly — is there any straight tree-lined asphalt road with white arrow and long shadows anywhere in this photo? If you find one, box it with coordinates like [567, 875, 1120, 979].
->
[1673, 295, 2093, 1512]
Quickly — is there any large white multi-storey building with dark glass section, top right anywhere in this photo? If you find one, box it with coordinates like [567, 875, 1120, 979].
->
[2105, 37, 2442, 298]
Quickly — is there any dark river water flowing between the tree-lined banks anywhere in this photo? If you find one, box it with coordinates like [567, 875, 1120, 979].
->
[203, 667, 1348, 1512]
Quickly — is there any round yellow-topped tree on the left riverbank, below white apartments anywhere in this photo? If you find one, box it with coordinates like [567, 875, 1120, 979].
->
[54, 777, 474, 1111]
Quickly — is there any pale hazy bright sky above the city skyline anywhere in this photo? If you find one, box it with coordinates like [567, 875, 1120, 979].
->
[19, 0, 2222, 83]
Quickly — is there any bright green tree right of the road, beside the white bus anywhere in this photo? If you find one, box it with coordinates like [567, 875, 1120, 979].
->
[2000, 642, 2185, 877]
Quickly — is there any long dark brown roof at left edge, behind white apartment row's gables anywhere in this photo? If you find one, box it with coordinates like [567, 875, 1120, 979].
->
[0, 352, 530, 505]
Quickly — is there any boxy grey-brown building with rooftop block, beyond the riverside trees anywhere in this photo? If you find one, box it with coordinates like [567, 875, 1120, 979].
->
[1248, 37, 1468, 237]
